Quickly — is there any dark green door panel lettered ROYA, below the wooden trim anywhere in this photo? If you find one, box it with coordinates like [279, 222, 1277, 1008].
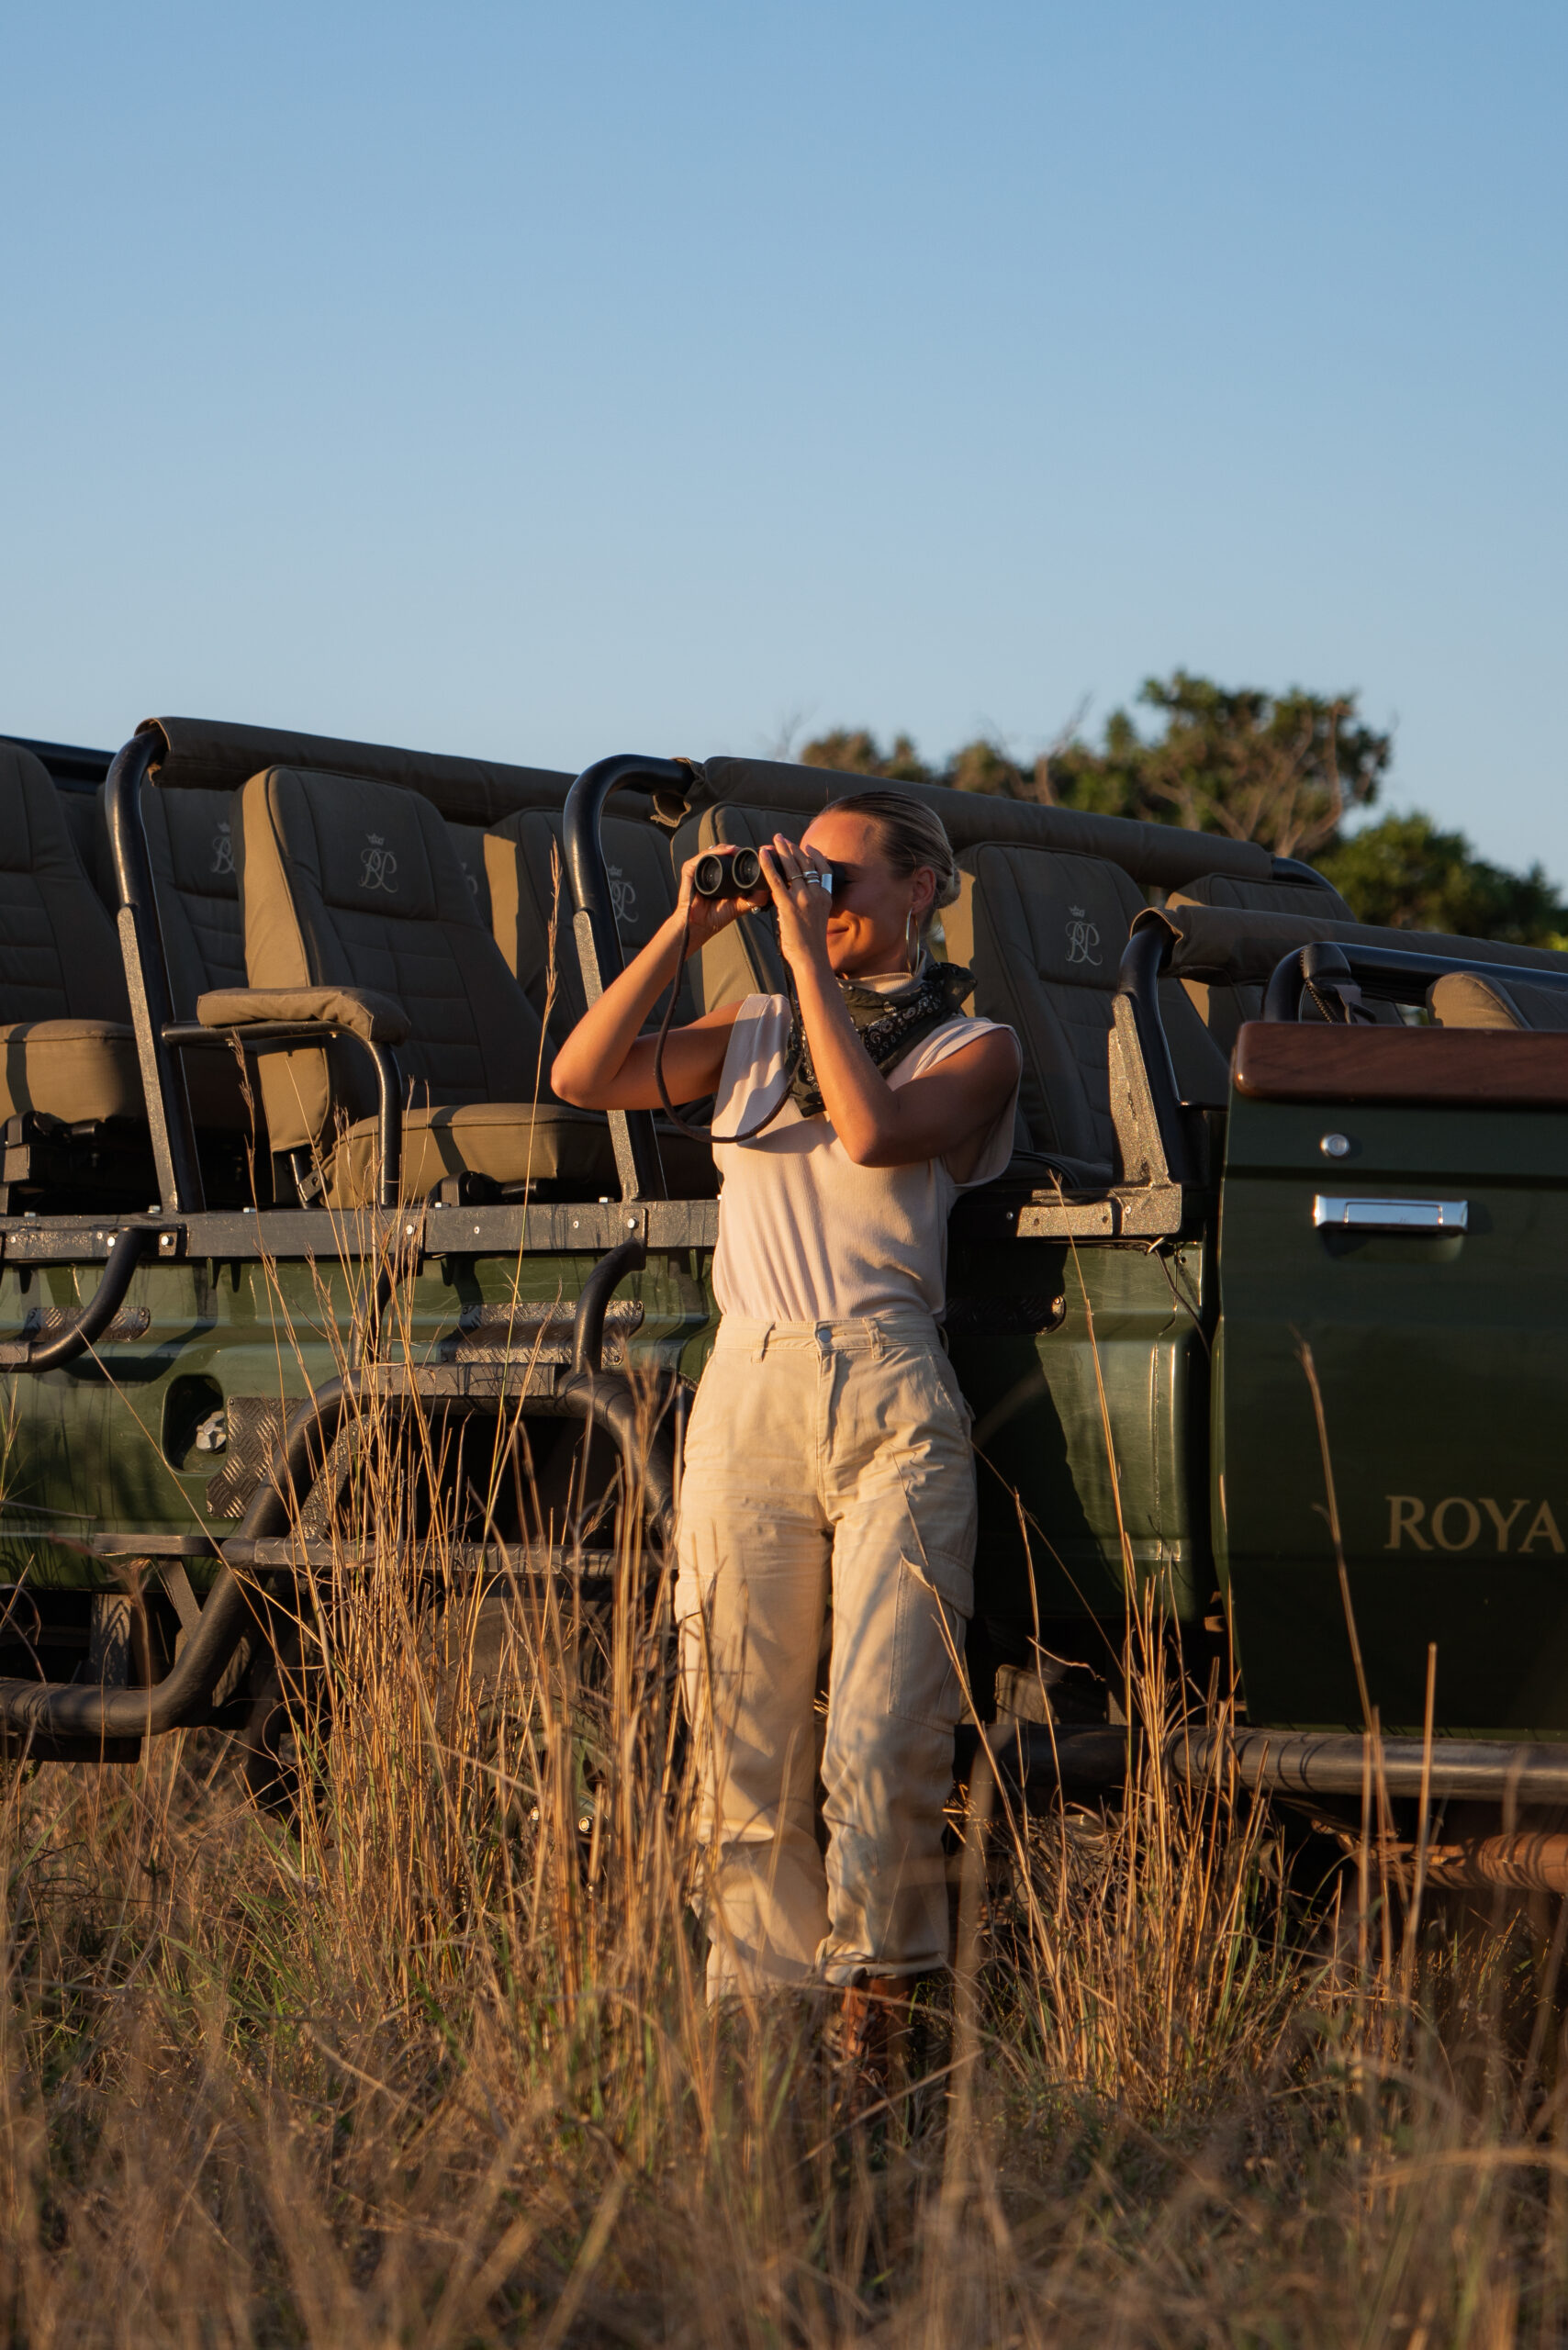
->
[1215, 1076, 1568, 1739]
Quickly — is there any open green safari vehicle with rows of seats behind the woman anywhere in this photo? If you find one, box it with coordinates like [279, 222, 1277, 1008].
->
[0, 719, 1568, 1885]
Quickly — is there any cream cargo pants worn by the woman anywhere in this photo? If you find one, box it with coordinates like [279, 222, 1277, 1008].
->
[675, 1309, 976, 1998]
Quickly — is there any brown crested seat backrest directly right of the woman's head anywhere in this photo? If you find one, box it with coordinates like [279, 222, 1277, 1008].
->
[943, 844, 1225, 1180]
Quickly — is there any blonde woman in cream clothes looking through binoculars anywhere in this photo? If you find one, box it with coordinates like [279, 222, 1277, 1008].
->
[553, 789, 1020, 2026]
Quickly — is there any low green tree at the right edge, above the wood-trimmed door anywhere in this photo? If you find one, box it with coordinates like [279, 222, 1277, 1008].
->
[1316, 813, 1568, 947]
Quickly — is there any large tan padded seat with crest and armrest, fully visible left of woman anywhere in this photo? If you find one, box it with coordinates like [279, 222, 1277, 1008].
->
[240, 767, 613, 1205]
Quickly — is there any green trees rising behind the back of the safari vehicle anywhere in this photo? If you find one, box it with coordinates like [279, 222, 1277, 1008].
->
[800, 670, 1568, 947]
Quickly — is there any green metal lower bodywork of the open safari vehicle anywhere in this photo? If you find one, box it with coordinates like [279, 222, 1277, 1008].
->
[0, 714, 1568, 1795]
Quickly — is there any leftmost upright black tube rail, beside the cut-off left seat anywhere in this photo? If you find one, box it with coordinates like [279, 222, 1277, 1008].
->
[104, 726, 207, 1215]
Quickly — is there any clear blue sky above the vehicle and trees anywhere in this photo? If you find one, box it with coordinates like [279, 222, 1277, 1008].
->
[0, 0, 1568, 881]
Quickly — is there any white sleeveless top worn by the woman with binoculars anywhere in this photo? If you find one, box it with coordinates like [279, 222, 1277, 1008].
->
[712, 996, 1018, 1323]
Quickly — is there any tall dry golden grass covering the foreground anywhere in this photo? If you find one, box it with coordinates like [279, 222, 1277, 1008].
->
[0, 1249, 1568, 2350]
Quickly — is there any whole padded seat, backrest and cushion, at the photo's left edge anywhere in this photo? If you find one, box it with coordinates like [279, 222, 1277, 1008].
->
[0, 740, 143, 1125]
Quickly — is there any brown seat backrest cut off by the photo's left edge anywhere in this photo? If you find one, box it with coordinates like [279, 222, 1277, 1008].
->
[0, 740, 129, 1024]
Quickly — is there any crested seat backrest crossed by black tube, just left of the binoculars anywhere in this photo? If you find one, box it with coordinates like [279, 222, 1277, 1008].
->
[485, 806, 700, 1050]
